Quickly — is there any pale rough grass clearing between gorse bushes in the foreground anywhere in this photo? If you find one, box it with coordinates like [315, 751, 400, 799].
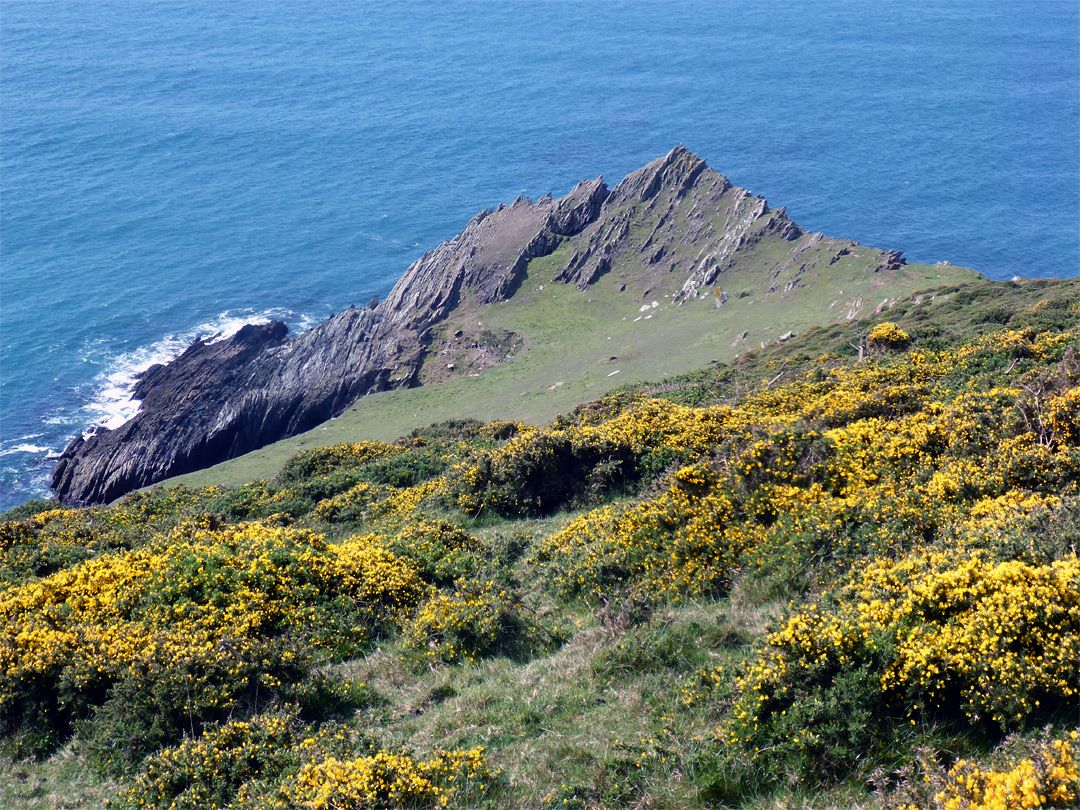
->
[328, 599, 794, 808]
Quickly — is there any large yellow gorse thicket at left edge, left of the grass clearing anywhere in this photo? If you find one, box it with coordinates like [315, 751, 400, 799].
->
[0, 524, 428, 760]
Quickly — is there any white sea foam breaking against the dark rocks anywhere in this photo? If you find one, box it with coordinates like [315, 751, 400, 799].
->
[80, 309, 319, 438]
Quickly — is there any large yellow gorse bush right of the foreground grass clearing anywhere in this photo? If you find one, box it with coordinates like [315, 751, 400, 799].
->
[727, 552, 1080, 770]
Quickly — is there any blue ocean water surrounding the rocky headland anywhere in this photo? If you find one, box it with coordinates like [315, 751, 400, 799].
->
[0, 0, 1080, 509]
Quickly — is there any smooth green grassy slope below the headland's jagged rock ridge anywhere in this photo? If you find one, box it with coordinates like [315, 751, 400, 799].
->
[168, 249, 988, 494]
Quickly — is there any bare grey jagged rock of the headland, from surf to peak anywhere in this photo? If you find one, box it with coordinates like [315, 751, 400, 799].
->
[52, 147, 902, 504]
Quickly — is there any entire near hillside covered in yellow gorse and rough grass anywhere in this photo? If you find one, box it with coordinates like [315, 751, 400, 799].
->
[0, 282, 1080, 810]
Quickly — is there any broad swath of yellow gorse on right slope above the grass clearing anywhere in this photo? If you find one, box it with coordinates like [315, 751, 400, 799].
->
[531, 333, 1080, 596]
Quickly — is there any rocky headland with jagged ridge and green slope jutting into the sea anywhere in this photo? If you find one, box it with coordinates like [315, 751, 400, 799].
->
[52, 147, 980, 505]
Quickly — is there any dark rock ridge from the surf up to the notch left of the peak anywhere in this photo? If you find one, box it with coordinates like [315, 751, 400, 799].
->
[52, 171, 608, 504]
